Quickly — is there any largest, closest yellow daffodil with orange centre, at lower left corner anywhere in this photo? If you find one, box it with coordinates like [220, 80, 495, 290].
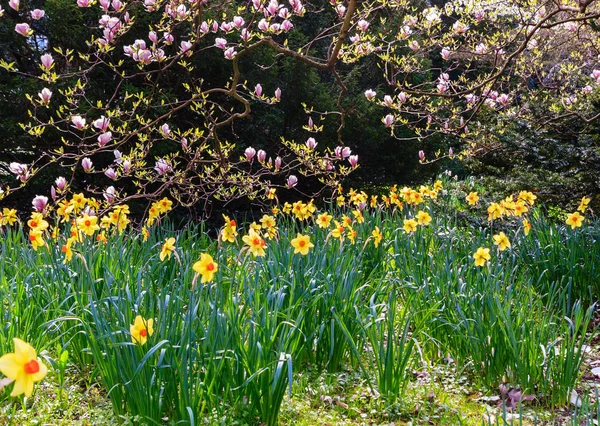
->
[0, 338, 48, 398]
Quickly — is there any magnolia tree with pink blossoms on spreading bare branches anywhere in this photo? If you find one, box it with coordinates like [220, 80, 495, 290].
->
[0, 0, 600, 213]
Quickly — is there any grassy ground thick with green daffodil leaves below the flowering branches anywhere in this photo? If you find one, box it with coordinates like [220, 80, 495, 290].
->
[0, 178, 600, 426]
